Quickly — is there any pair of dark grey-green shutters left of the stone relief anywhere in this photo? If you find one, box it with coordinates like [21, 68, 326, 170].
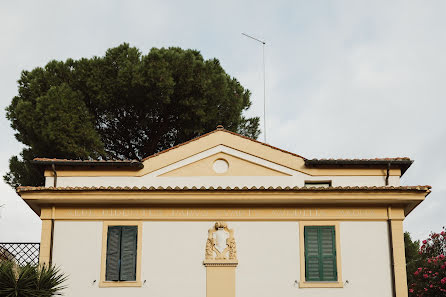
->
[105, 226, 138, 281]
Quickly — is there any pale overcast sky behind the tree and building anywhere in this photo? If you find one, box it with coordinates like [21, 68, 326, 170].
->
[0, 0, 446, 242]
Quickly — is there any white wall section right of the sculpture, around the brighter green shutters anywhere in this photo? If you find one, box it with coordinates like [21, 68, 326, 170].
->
[233, 222, 392, 297]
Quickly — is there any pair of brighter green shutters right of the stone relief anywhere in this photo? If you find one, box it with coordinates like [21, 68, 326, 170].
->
[304, 226, 338, 281]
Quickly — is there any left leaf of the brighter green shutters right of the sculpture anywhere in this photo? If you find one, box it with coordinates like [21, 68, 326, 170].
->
[304, 226, 320, 281]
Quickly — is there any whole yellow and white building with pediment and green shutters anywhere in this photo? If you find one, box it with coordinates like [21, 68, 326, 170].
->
[18, 127, 430, 297]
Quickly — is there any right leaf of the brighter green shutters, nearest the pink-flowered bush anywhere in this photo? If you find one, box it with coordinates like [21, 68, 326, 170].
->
[319, 226, 338, 281]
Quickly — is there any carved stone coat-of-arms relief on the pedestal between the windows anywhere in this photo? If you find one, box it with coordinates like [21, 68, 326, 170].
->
[205, 222, 237, 261]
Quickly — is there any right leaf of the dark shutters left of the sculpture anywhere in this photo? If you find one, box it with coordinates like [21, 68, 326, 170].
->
[120, 226, 138, 281]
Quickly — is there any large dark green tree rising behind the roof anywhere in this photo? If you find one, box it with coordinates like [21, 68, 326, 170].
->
[4, 44, 260, 187]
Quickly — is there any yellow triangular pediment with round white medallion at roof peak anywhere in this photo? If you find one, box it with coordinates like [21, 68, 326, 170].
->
[140, 130, 305, 177]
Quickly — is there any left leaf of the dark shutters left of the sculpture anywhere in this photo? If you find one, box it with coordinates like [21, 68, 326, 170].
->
[105, 226, 121, 281]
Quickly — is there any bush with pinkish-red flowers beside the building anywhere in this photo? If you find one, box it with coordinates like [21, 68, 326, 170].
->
[408, 227, 446, 297]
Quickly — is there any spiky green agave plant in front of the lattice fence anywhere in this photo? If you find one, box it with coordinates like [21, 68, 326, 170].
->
[0, 261, 67, 297]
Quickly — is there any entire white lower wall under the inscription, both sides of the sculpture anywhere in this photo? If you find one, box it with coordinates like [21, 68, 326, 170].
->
[53, 221, 391, 297]
